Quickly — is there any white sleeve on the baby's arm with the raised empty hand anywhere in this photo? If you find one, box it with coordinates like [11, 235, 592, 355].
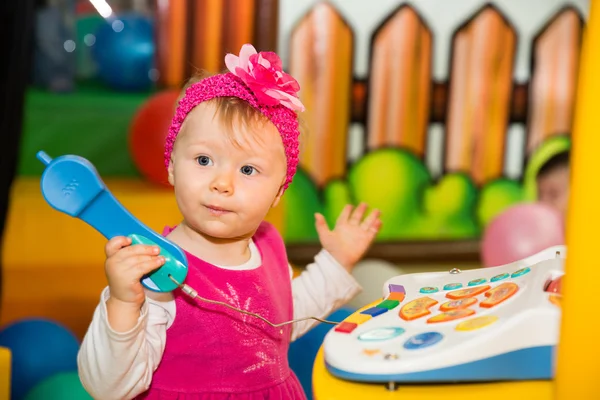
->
[290, 250, 362, 341]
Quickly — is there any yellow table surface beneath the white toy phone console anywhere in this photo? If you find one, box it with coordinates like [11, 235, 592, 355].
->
[313, 348, 554, 400]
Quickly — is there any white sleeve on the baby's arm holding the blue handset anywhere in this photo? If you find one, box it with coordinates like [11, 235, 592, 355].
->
[77, 287, 175, 400]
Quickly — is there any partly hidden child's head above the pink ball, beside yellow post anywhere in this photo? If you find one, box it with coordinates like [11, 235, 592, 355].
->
[536, 150, 570, 216]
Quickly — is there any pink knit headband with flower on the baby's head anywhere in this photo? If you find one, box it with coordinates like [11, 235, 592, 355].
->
[165, 44, 304, 189]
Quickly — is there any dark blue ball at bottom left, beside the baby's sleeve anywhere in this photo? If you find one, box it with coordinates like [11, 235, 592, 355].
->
[0, 319, 79, 400]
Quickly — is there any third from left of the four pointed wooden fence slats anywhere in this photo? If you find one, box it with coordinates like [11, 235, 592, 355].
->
[446, 6, 516, 184]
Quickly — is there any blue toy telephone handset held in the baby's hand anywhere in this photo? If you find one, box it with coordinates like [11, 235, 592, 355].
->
[37, 151, 188, 292]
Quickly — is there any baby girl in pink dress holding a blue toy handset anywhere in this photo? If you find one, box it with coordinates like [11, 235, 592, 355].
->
[78, 45, 381, 400]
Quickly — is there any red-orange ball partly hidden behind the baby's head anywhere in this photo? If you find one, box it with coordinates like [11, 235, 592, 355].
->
[129, 90, 180, 187]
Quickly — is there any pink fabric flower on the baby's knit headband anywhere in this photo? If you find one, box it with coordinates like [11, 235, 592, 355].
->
[225, 44, 304, 111]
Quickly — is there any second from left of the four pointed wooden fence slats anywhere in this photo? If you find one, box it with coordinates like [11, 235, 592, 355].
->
[367, 6, 432, 156]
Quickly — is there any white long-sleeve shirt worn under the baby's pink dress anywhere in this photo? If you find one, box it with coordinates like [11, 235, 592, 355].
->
[77, 242, 361, 400]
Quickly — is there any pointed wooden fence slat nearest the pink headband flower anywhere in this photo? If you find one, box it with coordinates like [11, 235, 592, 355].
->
[290, 3, 353, 185]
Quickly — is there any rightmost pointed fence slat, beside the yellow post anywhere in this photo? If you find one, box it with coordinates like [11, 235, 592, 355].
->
[527, 9, 583, 153]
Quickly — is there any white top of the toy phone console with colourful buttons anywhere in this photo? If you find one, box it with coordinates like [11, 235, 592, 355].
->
[324, 253, 562, 382]
